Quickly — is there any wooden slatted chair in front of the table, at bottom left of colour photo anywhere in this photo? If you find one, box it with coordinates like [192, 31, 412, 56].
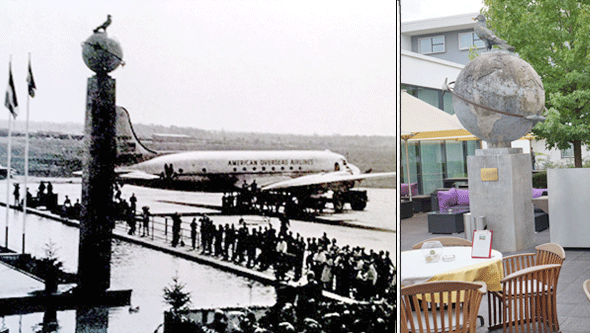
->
[400, 281, 483, 333]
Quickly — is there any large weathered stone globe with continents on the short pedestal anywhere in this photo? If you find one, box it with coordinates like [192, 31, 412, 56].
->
[453, 51, 545, 147]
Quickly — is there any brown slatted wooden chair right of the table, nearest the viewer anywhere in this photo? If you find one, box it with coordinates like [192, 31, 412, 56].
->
[501, 264, 561, 333]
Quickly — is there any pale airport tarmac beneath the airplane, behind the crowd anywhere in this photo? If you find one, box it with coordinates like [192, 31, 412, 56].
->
[0, 176, 396, 254]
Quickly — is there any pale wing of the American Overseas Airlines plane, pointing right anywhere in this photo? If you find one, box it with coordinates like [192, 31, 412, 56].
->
[261, 171, 396, 191]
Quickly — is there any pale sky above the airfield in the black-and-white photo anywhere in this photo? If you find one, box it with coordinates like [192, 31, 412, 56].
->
[0, 0, 397, 135]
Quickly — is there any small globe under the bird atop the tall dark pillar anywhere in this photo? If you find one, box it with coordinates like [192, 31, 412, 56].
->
[82, 32, 123, 73]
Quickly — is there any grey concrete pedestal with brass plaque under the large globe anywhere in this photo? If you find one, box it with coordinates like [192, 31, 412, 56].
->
[467, 148, 535, 252]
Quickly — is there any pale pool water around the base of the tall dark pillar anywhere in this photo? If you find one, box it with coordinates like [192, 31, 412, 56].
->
[6, 236, 275, 332]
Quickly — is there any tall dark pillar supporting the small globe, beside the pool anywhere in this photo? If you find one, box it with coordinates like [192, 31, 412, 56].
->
[78, 74, 116, 298]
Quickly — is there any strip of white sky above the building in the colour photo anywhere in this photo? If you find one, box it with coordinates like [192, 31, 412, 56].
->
[401, 0, 483, 22]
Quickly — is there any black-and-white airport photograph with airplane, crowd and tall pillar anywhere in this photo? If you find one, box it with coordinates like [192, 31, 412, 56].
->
[0, 0, 400, 333]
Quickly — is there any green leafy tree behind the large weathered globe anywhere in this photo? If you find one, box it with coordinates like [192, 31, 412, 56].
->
[484, 0, 590, 168]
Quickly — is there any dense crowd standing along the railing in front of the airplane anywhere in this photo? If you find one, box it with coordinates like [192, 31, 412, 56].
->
[172, 214, 395, 300]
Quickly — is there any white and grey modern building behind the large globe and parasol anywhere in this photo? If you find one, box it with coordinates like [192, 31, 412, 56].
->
[400, 13, 590, 194]
